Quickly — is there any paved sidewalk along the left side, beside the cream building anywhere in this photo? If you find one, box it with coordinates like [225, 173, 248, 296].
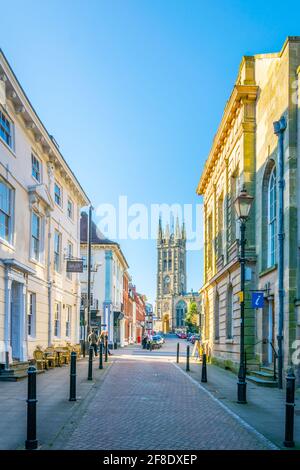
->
[0, 358, 112, 450]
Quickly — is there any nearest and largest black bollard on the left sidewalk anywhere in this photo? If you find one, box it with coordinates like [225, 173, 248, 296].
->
[25, 366, 38, 450]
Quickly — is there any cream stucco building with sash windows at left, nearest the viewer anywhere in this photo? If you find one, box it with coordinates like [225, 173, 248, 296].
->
[0, 51, 89, 370]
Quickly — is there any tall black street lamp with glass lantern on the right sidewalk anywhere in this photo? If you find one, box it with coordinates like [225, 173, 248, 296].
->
[234, 187, 254, 403]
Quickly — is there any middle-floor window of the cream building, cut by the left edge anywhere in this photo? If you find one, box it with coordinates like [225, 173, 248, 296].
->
[0, 178, 13, 243]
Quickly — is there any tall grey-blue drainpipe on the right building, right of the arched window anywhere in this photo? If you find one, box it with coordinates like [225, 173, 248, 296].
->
[273, 116, 286, 388]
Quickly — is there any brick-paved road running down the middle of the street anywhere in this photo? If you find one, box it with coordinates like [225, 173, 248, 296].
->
[65, 357, 276, 450]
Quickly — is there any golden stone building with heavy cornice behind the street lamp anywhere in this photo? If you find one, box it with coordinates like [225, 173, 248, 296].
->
[197, 37, 300, 382]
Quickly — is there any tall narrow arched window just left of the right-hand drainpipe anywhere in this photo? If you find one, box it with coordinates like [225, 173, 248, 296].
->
[268, 166, 276, 268]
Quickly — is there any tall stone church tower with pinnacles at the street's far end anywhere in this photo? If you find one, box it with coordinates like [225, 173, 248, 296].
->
[156, 217, 186, 332]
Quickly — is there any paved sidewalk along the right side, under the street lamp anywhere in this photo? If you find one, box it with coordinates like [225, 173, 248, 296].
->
[179, 360, 300, 449]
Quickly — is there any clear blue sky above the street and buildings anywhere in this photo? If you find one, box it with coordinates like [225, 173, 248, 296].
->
[0, 0, 300, 300]
